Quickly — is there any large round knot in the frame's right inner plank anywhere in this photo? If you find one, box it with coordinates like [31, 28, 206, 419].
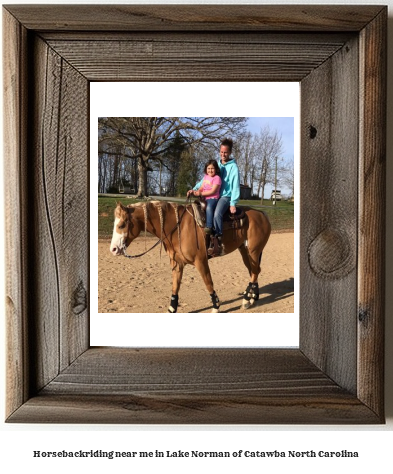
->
[308, 228, 355, 279]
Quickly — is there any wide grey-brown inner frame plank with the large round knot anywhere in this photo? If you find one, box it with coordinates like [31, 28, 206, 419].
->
[300, 36, 359, 394]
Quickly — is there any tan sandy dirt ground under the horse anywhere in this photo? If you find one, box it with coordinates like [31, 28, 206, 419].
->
[98, 233, 294, 313]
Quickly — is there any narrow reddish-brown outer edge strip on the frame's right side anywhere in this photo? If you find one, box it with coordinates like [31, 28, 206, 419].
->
[358, 10, 387, 418]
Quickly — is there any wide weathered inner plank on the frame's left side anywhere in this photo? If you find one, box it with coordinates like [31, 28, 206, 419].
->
[30, 37, 89, 387]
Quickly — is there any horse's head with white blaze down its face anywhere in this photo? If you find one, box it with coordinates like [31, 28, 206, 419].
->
[110, 203, 142, 255]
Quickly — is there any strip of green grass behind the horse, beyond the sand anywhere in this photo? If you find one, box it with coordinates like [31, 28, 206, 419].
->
[98, 195, 294, 238]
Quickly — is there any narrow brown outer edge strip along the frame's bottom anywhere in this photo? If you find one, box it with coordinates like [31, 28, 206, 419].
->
[9, 393, 380, 425]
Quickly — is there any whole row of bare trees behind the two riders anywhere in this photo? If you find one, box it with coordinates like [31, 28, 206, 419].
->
[98, 117, 294, 202]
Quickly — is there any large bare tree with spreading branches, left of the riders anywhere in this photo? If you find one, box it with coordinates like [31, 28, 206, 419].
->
[99, 117, 247, 197]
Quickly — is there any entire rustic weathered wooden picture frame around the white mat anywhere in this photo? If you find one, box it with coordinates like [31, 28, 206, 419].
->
[3, 5, 387, 424]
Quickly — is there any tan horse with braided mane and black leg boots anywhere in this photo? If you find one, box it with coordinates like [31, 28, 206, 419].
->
[110, 201, 271, 313]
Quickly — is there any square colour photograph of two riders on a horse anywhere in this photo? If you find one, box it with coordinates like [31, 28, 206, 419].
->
[97, 115, 298, 313]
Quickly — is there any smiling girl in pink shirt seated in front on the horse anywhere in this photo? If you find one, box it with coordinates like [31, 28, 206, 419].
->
[187, 160, 221, 234]
